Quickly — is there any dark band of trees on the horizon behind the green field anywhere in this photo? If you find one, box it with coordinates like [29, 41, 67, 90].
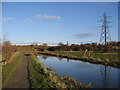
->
[35, 42, 120, 52]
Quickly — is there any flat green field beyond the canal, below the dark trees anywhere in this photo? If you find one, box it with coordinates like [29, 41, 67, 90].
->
[54, 51, 118, 60]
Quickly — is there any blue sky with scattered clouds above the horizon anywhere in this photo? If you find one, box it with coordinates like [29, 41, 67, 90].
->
[2, 2, 118, 45]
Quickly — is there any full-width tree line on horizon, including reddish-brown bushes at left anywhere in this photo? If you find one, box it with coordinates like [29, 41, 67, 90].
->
[0, 41, 120, 60]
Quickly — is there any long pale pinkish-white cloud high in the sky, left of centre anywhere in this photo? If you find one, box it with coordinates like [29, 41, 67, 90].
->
[33, 15, 61, 20]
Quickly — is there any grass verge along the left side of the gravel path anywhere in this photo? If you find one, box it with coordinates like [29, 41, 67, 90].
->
[2, 53, 23, 88]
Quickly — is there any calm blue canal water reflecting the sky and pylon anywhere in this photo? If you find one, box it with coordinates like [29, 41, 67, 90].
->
[38, 55, 119, 88]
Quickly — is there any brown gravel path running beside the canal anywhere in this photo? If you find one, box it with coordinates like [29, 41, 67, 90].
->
[6, 56, 30, 88]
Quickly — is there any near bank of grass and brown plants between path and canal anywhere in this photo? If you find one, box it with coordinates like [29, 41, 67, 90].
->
[28, 56, 91, 88]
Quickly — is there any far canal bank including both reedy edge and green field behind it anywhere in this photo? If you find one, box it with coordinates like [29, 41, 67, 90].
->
[38, 51, 120, 68]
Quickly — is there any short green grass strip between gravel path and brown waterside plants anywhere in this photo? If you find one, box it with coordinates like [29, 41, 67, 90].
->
[28, 57, 49, 88]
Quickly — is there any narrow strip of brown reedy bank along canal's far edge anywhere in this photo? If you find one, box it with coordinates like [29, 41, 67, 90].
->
[37, 52, 120, 68]
